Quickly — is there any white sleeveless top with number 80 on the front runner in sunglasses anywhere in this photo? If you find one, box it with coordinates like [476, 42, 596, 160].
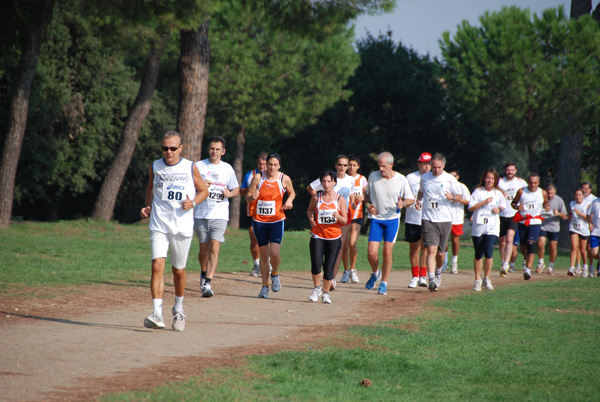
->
[150, 158, 196, 237]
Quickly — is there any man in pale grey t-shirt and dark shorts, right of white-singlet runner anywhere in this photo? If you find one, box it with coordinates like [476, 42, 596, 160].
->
[536, 183, 569, 275]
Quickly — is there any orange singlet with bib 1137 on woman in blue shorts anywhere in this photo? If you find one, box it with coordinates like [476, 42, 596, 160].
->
[252, 172, 285, 222]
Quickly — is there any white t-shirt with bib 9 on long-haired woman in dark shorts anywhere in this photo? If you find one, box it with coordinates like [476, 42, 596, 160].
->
[469, 187, 506, 237]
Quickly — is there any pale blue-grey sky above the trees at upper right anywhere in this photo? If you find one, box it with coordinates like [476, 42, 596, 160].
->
[354, 0, 576, 58]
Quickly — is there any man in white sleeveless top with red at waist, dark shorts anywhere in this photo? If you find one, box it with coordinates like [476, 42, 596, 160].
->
[511, 173, 550, 280]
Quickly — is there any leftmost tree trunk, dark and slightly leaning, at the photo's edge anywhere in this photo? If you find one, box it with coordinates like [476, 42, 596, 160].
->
[0, 0, 54, 229]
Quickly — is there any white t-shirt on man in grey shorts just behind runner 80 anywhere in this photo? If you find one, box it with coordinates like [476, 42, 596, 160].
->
[194, 159, 239, 221]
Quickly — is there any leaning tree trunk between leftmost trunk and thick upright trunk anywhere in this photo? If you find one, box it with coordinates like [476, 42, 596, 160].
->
[92, 37, 166, 221]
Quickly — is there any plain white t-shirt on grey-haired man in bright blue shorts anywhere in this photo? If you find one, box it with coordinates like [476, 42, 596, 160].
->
[367, 170, 415, 221]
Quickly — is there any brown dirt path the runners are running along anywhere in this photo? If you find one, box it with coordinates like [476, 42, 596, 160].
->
[0, 270, 567, 401]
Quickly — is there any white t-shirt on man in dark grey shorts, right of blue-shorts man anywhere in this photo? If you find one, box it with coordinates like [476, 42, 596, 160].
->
[421, 172, 462, 222]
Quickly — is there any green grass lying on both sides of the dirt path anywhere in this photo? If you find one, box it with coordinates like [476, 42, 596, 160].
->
[0, 221, 600, 401]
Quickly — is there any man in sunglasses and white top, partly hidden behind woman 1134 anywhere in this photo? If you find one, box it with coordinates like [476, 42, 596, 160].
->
[306, 155, 354, 290]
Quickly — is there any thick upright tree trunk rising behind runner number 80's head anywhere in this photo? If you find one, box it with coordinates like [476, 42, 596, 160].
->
[177, 20, 210, 162]
